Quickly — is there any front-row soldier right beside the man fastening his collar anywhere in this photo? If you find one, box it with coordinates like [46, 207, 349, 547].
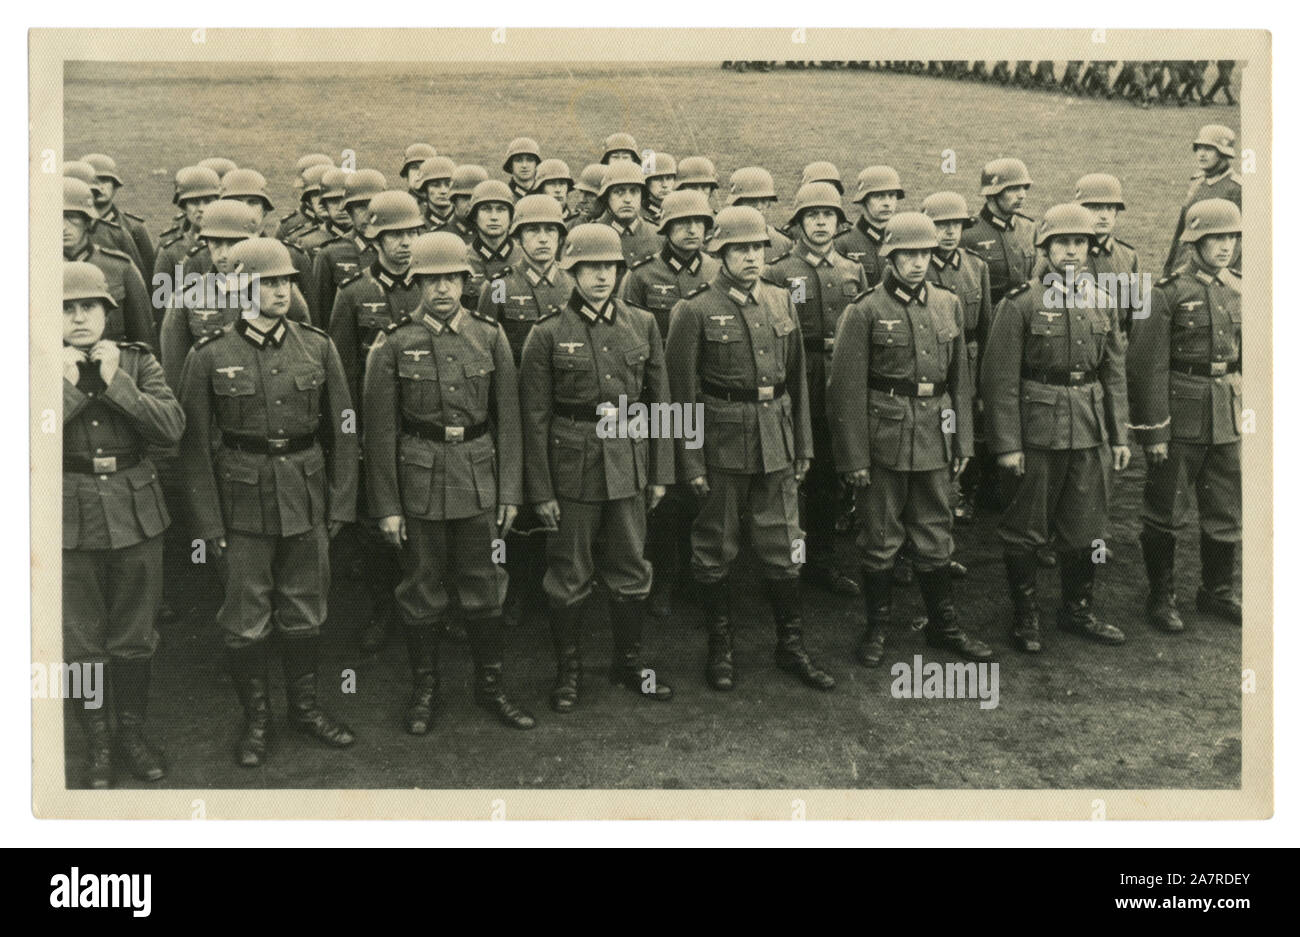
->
[181, 238, 358, 767]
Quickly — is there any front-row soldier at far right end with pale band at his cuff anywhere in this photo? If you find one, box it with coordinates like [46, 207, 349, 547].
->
[1128, 199, 1242, 632]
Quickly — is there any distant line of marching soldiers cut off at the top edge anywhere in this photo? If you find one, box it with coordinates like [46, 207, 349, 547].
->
[723, 58, 1236, 108]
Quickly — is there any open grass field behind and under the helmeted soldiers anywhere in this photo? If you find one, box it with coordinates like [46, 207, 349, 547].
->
[64, 58, 1242, 790]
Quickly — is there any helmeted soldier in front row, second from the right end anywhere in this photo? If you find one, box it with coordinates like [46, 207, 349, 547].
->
[980, 204, 1130, 654]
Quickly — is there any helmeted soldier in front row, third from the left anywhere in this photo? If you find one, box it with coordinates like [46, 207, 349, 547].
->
[364, 232, 536, 736]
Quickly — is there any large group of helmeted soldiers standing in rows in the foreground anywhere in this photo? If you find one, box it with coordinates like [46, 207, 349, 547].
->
[62, 118, 1242, 788]
